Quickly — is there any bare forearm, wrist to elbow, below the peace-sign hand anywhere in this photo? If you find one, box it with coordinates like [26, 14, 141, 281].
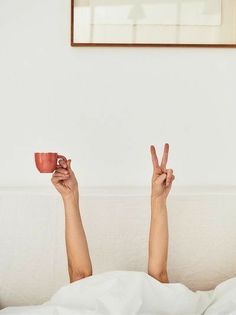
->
[148, 197, 168, 282]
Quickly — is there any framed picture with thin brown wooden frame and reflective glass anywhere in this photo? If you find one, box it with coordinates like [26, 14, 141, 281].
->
[71, 0, 236, 47]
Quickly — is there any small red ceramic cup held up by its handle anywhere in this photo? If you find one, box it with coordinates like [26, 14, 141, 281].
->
[34, 152, 67, 173]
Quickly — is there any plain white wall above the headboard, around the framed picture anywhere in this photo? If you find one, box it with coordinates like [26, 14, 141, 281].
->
[0, 0, 236, 186]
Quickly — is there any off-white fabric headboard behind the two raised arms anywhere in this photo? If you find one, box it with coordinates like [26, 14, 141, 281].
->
[0, 187, 236, 308]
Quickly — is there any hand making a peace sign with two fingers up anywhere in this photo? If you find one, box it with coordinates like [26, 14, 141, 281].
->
[150, 143, 175, 200]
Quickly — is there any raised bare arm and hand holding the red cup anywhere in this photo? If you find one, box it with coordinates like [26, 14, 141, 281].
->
[52, 160, 92, 282]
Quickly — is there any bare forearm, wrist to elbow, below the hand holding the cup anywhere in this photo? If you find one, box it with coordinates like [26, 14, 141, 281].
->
[63, 196, 92, 282]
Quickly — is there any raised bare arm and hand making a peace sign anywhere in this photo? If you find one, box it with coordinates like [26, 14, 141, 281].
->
[148, 143, 175, 282]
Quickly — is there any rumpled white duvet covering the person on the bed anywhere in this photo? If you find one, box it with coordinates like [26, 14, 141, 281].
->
[0, 271, 236, 315]
